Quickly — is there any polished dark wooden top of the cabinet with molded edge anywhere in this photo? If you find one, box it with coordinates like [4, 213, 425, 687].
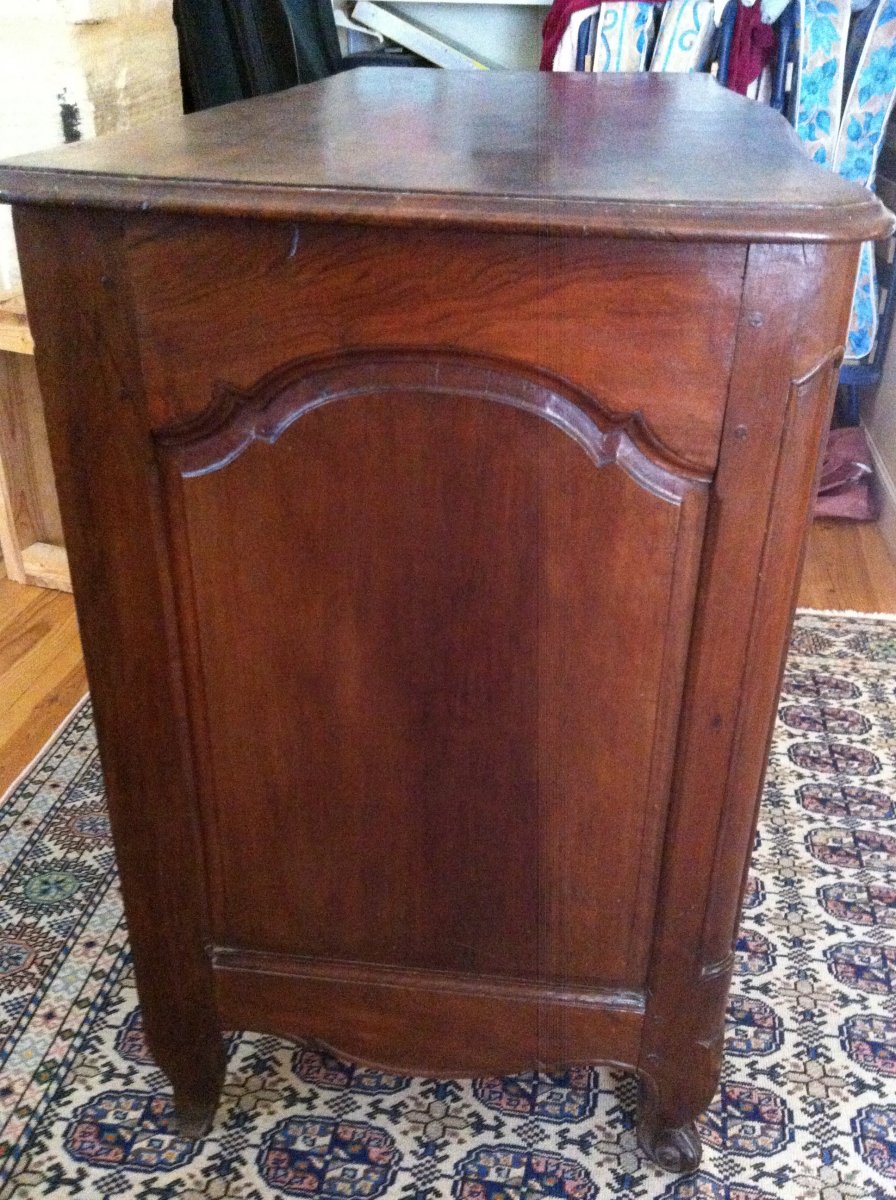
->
[0, 67, 892, 241]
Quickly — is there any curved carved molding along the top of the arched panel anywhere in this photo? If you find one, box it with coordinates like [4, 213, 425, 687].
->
[155, 350, 709, 504]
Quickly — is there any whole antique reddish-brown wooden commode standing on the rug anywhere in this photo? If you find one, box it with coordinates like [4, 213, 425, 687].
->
[0, 70, 891, 1170]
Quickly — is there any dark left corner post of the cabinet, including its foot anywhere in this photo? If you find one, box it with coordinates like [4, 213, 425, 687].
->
[14, 209, 223, 1114]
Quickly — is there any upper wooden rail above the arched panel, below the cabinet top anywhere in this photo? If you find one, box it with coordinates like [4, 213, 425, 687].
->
[122, 216, 746, 468]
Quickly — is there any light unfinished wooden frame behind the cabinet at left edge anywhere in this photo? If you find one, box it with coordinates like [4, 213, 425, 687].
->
[0, 293, 72, 592]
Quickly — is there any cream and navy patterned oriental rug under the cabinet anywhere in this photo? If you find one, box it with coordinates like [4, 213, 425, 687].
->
[0, 613, 896, 1200]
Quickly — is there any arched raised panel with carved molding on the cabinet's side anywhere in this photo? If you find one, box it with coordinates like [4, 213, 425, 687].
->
[157, 353, 706, 988]
